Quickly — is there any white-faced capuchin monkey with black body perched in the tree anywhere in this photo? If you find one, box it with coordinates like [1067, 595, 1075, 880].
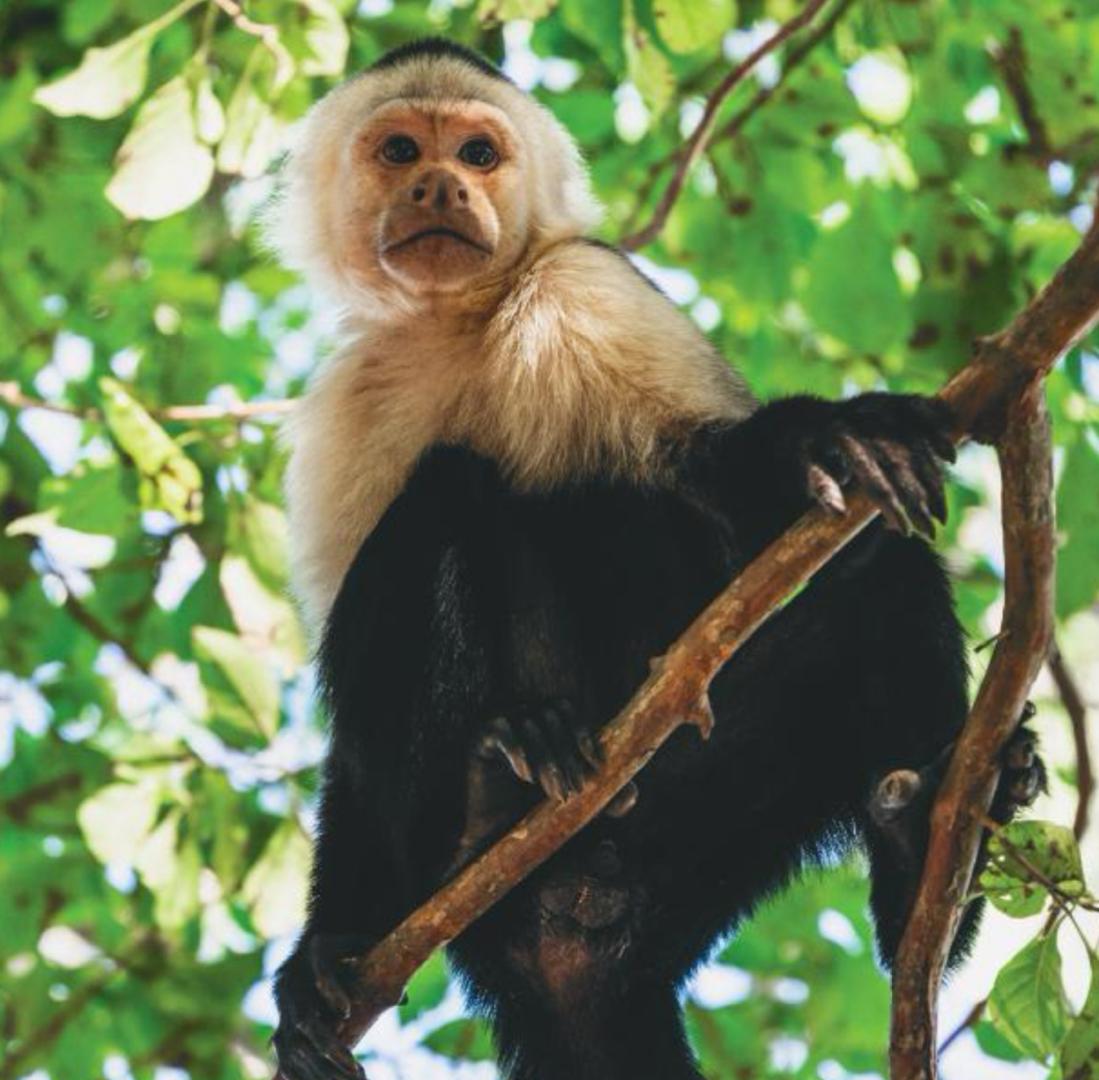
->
[273, 40, 1044, 1080]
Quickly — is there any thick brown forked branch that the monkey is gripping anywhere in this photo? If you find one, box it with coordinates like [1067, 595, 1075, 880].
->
[272, 206, 1099, 1080]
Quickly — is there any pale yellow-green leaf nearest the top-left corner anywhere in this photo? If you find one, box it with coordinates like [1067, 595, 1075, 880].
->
[34, 26, 153, 120]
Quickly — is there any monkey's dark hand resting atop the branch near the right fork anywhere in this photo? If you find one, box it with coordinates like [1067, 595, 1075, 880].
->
[804, 393, 956, 536]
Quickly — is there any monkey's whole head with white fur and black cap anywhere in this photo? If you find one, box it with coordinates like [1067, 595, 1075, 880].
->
[271, 40, 599, 318]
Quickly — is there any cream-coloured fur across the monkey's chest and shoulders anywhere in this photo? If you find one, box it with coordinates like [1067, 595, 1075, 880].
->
[287, 242, 753, 628]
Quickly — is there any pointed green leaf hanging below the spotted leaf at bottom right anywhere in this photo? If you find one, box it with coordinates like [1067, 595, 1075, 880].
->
[988, 933, 1068, 1060]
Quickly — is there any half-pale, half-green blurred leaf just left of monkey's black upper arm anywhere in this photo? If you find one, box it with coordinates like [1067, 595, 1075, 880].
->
[191, 626, 279, 739]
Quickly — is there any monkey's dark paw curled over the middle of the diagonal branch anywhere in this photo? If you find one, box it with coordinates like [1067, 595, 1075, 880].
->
[475, 698, 602, 802]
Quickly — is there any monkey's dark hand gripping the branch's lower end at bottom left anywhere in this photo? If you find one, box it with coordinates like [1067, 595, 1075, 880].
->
[271, 933, 368, 1080]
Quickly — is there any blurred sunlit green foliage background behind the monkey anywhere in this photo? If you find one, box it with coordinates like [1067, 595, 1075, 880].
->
[0, 0, 1099, 1080]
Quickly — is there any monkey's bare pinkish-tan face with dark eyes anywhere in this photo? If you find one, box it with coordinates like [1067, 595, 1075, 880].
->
[342, 101, 530, 296]
